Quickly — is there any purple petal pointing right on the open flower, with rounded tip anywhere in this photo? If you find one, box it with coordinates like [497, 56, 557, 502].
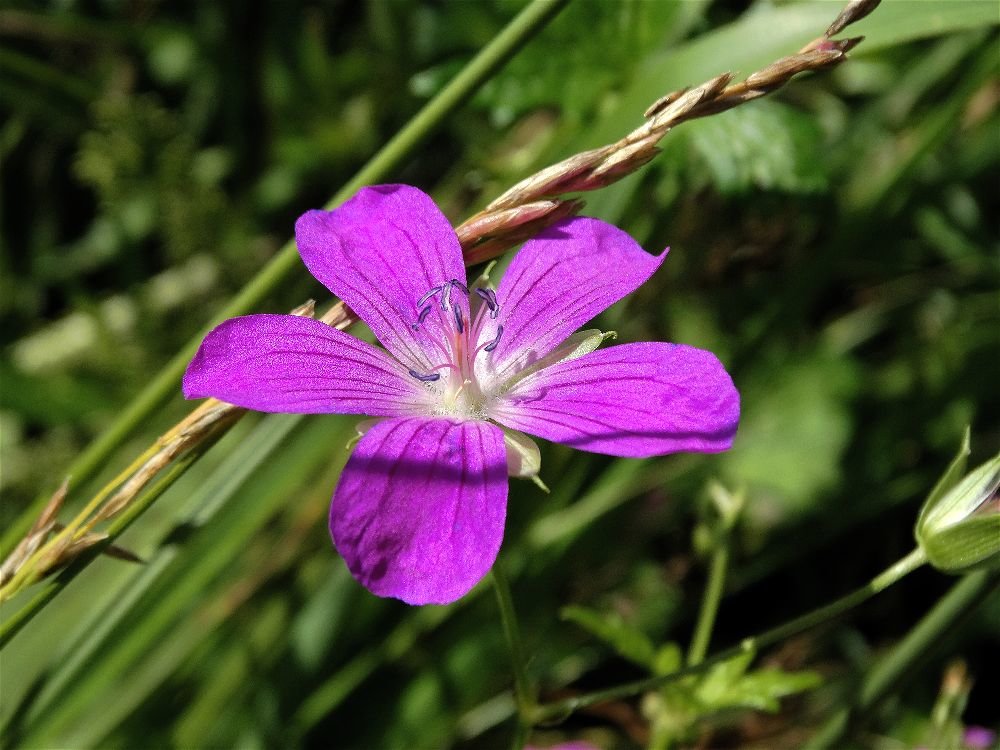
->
[490, 343, 740, 458]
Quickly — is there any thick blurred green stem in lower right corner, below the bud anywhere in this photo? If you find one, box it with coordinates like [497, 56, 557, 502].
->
[806, 571, 1000, 750]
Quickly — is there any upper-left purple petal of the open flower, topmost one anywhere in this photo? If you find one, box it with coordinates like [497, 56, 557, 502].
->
[295, 185, 469, 372]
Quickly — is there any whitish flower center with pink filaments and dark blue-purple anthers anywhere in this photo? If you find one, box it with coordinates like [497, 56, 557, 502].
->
[410, 279, 503, 419]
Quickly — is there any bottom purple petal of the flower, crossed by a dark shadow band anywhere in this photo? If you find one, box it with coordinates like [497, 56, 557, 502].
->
[330, 418, 507, 604]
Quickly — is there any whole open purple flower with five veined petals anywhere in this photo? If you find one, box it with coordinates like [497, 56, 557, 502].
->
[184, 185, 739, 604]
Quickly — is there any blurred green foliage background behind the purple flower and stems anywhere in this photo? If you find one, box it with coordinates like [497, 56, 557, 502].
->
[0, 0, 1000, 748]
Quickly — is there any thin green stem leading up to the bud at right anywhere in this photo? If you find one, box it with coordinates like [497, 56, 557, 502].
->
[531, 548, 927, 724]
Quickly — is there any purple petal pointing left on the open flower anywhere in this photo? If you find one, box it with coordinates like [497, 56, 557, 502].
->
[184, 315, 428, 416]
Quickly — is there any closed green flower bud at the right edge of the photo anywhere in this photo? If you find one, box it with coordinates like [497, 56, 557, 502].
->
[915, 454, 1000, 573]
